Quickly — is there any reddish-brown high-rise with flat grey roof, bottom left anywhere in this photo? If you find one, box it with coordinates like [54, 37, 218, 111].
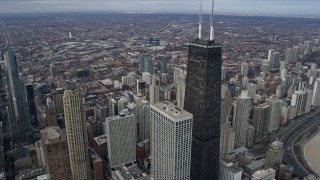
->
[41, 126, 71, 180]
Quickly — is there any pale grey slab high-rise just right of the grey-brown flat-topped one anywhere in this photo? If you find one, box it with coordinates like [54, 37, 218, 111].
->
[266, 97, 281, 133]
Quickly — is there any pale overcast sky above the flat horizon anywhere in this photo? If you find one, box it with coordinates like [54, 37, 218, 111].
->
[0, 0, 320, 17]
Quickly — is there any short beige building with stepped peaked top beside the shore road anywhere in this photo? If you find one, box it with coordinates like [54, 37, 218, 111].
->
[265, 139, 284, 168]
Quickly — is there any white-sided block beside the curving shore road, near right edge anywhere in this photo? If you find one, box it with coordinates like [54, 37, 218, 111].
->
[291, 91, 307, 116]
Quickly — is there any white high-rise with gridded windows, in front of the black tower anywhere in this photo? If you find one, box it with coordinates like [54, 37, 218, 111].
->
[151, 102, 193, 180]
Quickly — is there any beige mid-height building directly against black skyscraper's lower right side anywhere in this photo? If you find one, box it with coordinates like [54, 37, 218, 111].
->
[220, 124, 235, 160]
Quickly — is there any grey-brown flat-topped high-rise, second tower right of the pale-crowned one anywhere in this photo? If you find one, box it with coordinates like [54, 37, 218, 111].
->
[253, 104, 270, 141]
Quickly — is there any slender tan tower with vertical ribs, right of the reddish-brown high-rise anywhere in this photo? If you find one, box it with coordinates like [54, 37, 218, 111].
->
[63, 82, 90, 180]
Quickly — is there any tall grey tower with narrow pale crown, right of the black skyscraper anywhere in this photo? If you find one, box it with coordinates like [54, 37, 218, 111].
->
[232, 91, 251, 149]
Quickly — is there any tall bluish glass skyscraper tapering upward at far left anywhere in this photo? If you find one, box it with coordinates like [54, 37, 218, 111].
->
[4, 48, 31, 142]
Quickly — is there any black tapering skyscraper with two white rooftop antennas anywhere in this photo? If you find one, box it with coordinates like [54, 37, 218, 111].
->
[184, 2, 222, 180]
